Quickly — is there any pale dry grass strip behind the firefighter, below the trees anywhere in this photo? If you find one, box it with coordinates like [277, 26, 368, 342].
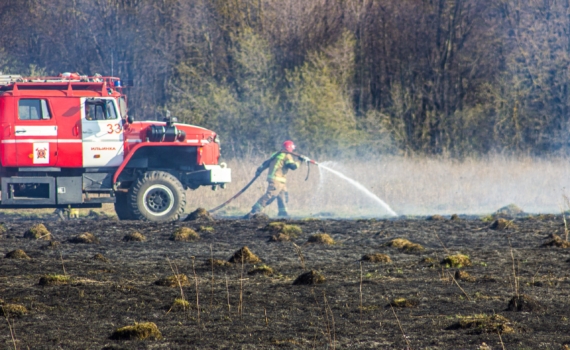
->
[182, 155, 570, 217]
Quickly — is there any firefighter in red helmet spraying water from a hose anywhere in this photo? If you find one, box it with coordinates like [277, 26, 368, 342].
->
[248, 140, 308, 216]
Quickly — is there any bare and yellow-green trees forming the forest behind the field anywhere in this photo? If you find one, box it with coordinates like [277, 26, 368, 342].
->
[0, 0, 570, 158]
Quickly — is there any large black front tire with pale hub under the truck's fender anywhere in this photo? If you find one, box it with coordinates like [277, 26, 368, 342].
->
[128, 171, 186, 222]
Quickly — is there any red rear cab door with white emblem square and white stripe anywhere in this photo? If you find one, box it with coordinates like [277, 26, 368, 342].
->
[14, 98, 57, 167]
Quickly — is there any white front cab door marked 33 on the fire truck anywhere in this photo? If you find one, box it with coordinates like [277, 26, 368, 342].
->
[81, 98, 124, 168]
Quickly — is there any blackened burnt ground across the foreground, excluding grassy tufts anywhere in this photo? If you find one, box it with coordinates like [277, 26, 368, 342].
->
[0, 216, 570, 349]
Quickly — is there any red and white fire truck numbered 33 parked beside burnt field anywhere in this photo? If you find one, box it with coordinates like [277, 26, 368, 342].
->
[0, 73, 231, 222]
